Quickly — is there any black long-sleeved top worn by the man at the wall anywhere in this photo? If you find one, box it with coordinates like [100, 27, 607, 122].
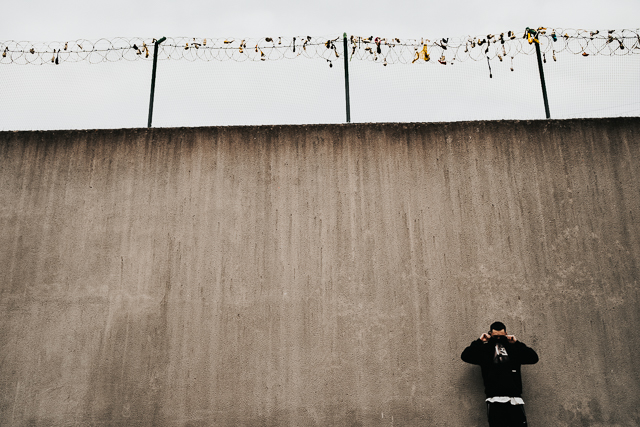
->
[461, 339, 538, 397]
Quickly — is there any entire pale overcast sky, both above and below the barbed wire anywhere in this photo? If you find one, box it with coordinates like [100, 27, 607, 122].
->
[0, 0, 640, 131]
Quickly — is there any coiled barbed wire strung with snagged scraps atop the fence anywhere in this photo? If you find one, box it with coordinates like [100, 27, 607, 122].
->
[0, 27, 640, 68]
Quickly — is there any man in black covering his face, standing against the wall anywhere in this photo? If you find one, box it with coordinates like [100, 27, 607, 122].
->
[461, 322, 538, 427]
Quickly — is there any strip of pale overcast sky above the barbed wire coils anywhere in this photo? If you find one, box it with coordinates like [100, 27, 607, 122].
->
[0, 0, 640, 41]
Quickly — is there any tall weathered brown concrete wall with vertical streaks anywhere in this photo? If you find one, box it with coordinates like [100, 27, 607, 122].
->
[0, 119, 640, 426]
